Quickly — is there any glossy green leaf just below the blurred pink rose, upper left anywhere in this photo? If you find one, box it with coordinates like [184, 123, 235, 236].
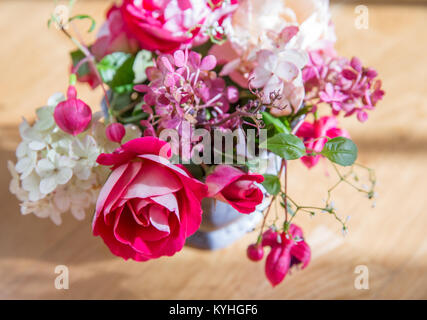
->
[97, 52, 135, 93]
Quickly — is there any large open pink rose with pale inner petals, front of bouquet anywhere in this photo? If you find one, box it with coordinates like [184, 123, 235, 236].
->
[92, 137, 206, 261]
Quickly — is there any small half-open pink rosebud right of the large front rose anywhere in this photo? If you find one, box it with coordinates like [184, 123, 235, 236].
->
[206, 165, 264, 213]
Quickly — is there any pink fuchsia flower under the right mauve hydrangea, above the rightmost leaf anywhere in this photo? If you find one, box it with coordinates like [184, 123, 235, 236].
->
[296, 116, 350, 168]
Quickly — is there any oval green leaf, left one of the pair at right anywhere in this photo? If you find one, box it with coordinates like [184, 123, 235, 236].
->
[267, 133, 306, 160]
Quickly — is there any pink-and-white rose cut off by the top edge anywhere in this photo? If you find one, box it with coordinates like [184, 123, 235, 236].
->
[121, 0, 237, 53]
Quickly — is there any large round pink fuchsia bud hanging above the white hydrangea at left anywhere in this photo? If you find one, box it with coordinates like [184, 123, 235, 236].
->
[53, 85, 92, 136]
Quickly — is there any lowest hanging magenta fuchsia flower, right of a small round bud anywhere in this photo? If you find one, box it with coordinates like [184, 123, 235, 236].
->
[262, 224, 311, 287]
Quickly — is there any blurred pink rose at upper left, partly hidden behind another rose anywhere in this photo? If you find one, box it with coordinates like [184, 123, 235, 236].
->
[91, 5, 139, 60]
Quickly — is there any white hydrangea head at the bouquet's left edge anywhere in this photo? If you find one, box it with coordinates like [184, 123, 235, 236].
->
[8, 93, 141, 225]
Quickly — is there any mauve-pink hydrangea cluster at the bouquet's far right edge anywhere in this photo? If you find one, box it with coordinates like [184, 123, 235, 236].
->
[303, 51, 384, 122]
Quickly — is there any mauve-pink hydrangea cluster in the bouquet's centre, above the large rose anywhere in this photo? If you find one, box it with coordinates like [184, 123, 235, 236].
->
[135, 50, 239, 135]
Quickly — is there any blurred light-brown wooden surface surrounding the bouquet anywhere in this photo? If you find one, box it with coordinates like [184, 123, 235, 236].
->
[0, 0, 427, 299]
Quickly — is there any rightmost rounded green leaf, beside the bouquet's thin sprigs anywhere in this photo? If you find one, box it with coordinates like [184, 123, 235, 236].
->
[321, 137, 357, 166]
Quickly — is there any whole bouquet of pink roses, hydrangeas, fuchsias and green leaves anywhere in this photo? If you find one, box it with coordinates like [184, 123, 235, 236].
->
[9, 0, 384, 286]
